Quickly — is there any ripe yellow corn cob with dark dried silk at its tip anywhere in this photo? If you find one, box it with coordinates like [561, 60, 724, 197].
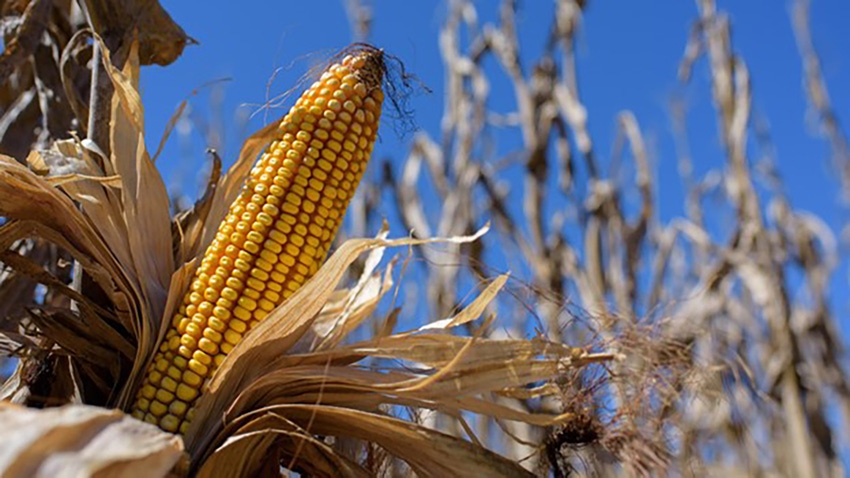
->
[132, 48, 384, 433]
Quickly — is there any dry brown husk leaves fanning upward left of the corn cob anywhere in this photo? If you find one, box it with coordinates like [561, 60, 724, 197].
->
[0, 40, 183, 407]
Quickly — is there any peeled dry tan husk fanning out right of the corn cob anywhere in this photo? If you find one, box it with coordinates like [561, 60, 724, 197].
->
[167, 225, 610, 476]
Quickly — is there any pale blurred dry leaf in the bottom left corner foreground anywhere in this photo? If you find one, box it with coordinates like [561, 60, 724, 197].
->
[0, 403, 183, 478]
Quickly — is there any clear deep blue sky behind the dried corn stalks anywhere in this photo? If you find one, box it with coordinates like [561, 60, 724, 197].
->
[142, 0, 850, 330]
